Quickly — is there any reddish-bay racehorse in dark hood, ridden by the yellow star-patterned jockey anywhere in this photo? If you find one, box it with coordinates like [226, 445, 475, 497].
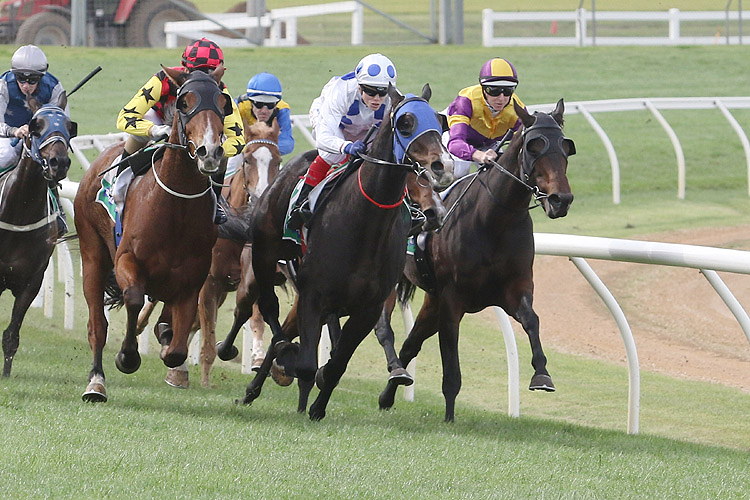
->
[75, 68, 232, 402]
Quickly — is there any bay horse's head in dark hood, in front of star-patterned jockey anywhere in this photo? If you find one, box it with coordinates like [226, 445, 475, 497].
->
[162, 66, 232, 176]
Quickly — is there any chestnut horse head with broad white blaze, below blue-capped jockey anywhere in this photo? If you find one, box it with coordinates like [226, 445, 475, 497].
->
[242, 120, 281, 203]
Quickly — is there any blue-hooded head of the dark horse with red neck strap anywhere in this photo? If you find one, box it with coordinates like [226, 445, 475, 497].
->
[388, 83, 455, 190]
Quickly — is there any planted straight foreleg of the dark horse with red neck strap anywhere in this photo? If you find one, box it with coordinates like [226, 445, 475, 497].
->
[310, 304, 382, 420]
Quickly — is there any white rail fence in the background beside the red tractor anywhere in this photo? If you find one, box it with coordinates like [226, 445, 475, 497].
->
[164, 1, 364, 49]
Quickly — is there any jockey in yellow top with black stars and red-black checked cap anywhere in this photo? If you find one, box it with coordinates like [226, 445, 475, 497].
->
[117, 38, 245, 224]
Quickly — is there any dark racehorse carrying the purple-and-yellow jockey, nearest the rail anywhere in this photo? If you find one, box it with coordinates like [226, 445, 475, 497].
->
[377, 99, 575, 421]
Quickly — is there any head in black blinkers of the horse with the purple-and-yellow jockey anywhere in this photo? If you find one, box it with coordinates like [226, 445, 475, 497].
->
[513, 99, 576, 219]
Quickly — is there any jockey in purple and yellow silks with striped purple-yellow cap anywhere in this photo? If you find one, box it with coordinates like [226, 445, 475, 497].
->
[448, 57, 525, 178]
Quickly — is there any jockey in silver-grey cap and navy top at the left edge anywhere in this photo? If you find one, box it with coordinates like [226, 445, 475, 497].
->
[0, 45, 70, 236]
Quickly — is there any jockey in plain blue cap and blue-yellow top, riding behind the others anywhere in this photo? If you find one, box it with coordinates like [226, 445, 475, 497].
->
[237, 72, 294, 155]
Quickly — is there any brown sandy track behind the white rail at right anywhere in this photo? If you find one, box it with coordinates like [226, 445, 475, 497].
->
[524, 226, 750, 392]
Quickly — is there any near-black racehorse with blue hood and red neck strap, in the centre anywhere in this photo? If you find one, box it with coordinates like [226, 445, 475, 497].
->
[226, 85, 453, 420]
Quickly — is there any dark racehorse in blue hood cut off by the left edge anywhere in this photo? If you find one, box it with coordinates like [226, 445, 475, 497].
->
[0, 94, 77, 377]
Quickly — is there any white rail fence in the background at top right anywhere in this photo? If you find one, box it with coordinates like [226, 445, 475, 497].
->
[482, 9, 742, 47]
